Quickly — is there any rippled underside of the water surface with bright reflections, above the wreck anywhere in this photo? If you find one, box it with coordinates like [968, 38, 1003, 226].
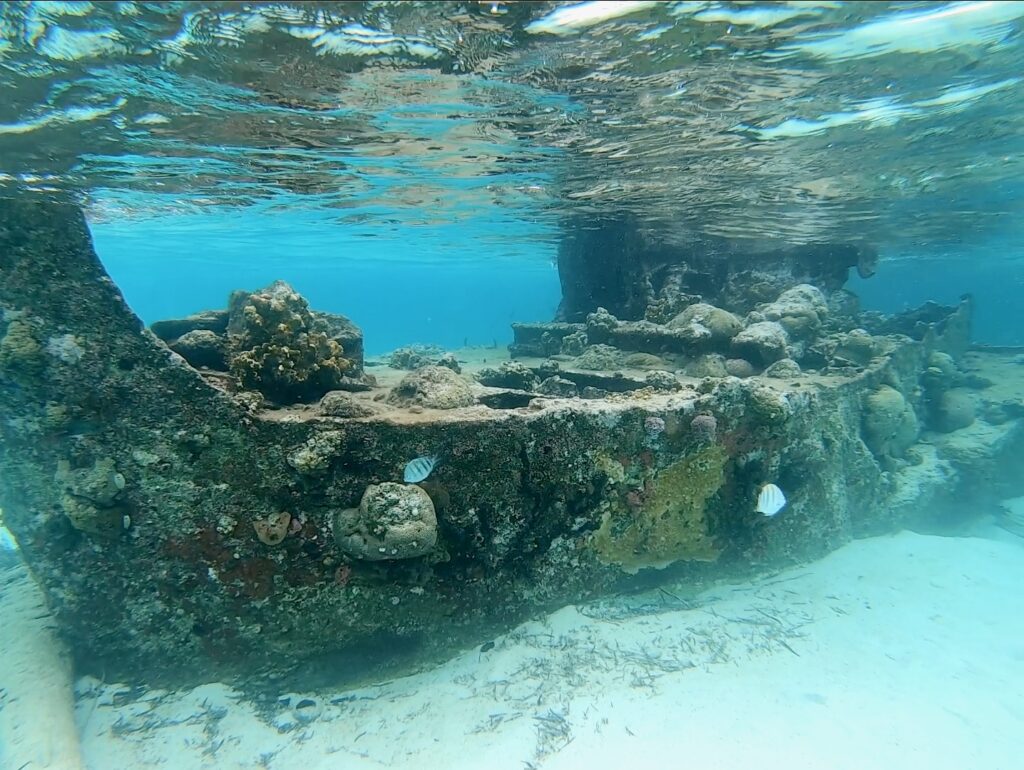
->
[0, 2, 1024, 243]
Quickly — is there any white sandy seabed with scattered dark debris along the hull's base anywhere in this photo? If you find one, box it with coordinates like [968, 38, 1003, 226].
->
[4, 533, 1024, 770]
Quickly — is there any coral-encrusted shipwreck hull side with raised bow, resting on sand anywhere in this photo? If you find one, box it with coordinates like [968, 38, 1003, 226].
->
[0, 195, 1019, 687]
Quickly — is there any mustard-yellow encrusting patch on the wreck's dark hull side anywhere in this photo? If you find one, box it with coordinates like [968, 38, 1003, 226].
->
[592, 444, 729, 573]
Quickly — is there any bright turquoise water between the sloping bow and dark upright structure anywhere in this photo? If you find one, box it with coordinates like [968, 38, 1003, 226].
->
[92, 204, 561, 353]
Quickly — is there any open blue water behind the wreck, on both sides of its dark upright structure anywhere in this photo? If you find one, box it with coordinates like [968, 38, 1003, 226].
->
[91, 212, 1024, 354]
